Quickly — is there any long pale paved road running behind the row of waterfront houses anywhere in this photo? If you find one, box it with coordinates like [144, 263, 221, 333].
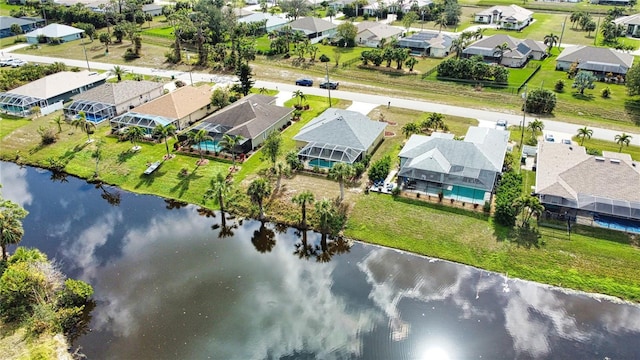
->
[3, 47, 640, 146]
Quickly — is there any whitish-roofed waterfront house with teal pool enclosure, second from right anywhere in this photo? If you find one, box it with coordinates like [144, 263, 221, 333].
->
[398, 126, 509, 204]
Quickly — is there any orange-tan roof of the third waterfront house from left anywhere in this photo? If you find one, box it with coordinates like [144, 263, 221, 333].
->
[131, 85, 211, 119]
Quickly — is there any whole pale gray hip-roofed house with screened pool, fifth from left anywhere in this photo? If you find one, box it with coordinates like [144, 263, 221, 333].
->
[293, 108, 387, 168]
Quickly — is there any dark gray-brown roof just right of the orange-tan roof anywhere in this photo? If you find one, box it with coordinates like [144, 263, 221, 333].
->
[201, 94, 293, 139]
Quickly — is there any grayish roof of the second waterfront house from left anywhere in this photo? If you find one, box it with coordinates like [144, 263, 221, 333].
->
[73, 80, 163, 105]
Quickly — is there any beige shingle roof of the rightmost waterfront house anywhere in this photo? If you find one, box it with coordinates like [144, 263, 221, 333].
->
[536, 142, 640, 202]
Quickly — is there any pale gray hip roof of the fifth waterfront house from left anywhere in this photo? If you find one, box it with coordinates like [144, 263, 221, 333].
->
[293, 108, 387, 151]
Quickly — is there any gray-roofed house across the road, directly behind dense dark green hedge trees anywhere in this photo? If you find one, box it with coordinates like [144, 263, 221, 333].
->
[462, 34, 547, 68]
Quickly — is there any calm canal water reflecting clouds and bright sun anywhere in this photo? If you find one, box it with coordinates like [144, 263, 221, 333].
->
[0, 163, 640, 360]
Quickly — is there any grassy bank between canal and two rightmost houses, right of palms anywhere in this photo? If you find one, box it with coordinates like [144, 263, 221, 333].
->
[345, 193, 640, 301]
